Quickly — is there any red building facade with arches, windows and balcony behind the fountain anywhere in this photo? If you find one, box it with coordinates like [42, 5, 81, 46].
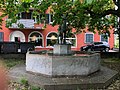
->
[0, 13, 114, 50]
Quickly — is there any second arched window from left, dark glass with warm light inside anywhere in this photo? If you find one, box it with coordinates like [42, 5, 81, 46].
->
[29, 32, 43, 46]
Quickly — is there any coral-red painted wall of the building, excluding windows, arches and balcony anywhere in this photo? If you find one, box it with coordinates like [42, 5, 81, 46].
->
[0, 12, 114, 50]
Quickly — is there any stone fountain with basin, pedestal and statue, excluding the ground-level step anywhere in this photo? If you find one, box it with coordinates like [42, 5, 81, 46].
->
[26, 15, 100, 77]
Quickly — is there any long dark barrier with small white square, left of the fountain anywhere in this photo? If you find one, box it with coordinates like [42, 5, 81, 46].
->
[0, 42, 35, 53]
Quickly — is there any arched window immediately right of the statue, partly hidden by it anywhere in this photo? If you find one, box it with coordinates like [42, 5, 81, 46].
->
[66, 33, 76, 47]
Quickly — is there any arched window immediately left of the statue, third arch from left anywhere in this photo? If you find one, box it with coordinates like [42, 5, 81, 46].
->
[47, 32, 58, 46]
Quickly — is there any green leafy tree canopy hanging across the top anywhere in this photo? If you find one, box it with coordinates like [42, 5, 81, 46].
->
[0, 0, 120, 57]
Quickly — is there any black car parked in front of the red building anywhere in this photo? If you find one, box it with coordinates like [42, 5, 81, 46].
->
[80, 42, 110, 52]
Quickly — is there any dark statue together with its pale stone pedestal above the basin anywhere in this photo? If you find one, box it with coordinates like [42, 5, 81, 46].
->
[53, 15, 71, 55]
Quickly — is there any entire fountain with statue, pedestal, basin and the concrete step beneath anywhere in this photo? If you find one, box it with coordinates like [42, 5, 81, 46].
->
[26, 15, 117, 90]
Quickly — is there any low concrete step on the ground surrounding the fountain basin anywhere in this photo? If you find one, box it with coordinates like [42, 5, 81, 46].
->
[8, 65, 118, 90]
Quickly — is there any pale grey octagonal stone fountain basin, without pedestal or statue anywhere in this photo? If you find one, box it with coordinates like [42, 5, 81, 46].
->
[26, 52, 101, 76]
